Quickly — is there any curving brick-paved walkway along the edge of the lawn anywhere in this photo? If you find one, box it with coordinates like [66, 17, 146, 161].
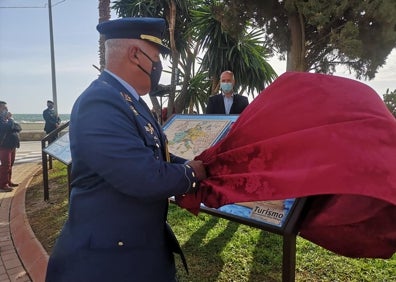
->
[0, 141, 48, 282]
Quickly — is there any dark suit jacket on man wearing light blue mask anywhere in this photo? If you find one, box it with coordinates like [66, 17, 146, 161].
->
[206, 94, 249, 115]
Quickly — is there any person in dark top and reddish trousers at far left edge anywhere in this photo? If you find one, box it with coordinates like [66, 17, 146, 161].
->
[0, 101, 22, 192]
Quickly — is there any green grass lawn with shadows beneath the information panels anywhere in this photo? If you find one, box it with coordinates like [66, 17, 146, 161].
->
[26, 161, 396, 282]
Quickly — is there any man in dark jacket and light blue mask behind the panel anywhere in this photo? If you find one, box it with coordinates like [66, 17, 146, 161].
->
[206, 71, 249, 115]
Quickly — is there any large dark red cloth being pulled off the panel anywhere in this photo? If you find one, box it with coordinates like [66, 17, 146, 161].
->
[177, 72, 396, 258]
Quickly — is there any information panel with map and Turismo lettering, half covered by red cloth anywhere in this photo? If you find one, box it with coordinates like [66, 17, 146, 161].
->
[163, 115, 297, 233]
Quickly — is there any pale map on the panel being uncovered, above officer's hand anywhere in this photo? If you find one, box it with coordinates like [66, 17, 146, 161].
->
[165, 118, 230, 160]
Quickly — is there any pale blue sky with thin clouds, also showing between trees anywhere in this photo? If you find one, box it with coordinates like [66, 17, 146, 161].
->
[0, 0, 396, 114]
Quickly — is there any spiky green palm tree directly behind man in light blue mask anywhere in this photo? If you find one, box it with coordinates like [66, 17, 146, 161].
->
[191, 2, 276, 96]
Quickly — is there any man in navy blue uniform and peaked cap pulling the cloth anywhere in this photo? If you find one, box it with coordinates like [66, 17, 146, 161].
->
[46, 18, 206, 282]
